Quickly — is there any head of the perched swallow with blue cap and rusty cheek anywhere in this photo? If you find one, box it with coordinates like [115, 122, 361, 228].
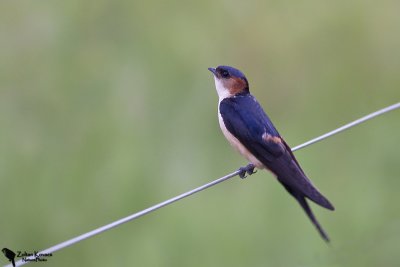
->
[208, 66, 249, 101]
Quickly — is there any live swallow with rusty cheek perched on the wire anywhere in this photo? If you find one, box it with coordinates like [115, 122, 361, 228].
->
[208, 66, 335, 242]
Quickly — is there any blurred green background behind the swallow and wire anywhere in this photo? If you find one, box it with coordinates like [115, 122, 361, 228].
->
[0, 0, 400, 266]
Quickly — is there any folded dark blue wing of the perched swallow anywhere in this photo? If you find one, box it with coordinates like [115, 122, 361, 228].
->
[219, 94, 333, 209]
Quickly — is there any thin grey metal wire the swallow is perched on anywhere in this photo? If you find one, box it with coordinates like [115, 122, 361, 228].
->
[6, 102, 400, 267]
